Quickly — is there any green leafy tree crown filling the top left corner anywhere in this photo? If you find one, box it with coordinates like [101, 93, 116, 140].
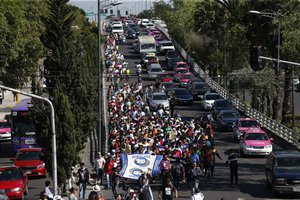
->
[0, 1, 43, 88]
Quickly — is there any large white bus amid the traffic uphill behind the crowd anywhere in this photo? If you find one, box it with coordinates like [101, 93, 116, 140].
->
[138, 35, 156, 54]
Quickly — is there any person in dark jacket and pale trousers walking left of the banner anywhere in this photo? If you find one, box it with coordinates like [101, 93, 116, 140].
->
[76, 162, 91, 200]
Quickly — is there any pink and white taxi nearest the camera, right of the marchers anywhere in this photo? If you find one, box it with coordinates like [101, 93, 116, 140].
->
[240, 128, 273, 156]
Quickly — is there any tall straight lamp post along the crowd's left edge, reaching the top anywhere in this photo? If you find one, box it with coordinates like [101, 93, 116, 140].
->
[97, 0, 123, 152]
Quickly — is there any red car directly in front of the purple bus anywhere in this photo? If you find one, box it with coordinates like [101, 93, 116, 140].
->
[12, 148, 47, 177]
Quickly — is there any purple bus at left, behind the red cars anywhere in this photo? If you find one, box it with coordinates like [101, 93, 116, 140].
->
[10, 98, 40, 152]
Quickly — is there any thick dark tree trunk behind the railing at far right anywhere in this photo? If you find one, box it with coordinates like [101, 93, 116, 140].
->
[282, 69, 293, 124]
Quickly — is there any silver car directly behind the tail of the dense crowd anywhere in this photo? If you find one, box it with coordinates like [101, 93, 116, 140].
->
[148, 92, 170, 110]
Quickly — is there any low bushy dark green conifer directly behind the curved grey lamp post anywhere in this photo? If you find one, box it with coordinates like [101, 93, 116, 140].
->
[31, 86, 79, 185]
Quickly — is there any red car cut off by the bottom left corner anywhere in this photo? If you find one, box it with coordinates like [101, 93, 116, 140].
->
[0, 166, 28, 200]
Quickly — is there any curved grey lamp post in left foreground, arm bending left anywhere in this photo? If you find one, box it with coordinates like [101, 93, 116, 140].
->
[0, 85, 58, 196]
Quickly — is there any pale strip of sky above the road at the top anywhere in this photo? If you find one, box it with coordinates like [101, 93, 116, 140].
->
[70, 0, 164, 21]
